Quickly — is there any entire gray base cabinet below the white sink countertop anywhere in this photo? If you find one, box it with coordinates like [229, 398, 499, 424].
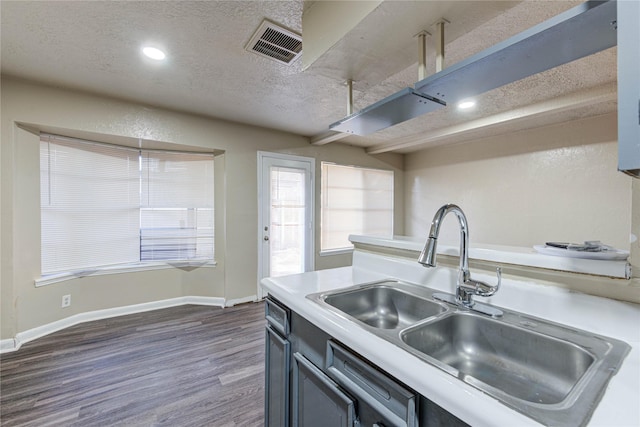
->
[265, 296, 466, 427]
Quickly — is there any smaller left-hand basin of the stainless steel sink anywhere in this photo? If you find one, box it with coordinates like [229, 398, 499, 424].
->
[324, 282, 446, 329]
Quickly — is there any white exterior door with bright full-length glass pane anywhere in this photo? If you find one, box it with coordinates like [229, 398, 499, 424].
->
[258, 151, 315, 296]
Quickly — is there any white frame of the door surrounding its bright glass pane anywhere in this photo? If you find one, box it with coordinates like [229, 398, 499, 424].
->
[257, 151, 316, 298]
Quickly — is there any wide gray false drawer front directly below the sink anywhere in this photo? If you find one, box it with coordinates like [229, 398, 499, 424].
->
[326, 341, 418, 427]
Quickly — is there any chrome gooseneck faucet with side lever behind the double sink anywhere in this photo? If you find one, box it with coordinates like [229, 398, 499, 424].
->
[418, 204, 502, 317]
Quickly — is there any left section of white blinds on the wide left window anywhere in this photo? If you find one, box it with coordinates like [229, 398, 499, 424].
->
[40, 137, 140, 273]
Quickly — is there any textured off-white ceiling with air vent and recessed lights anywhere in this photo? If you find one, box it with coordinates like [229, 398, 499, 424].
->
[0, 0, 616, 152]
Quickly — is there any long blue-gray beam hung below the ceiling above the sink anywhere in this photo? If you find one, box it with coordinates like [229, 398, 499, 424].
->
[329, 0, 617, 136]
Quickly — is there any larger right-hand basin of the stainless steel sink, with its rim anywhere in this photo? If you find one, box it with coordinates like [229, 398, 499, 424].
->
[399, 309, 630, 426]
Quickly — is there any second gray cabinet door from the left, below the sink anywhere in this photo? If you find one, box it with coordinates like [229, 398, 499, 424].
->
[292, 353, 356, 427]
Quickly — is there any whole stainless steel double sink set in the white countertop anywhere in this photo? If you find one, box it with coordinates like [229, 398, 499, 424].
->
[307, 280, 630, 426]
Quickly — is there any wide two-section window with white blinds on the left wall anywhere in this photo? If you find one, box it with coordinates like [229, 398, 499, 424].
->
[40, 135, 214, 275]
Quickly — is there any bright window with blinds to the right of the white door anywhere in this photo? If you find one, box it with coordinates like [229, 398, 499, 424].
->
[320, 162, 393, 251]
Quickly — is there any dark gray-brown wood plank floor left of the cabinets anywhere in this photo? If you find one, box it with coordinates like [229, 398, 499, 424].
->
[0, 303, 264, 427]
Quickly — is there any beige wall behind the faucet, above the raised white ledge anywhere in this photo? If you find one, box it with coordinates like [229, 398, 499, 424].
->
[405, 114, 637, 254]
